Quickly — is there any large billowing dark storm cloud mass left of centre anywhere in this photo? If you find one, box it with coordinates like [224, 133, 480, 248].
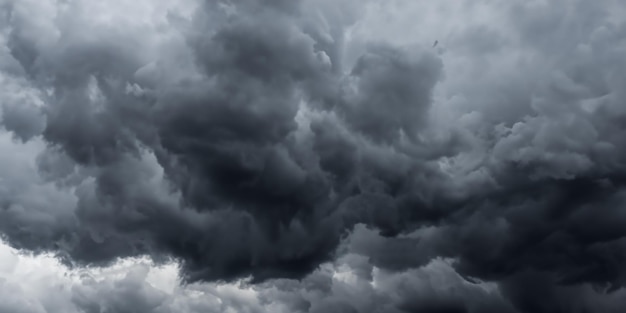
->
[0, 1, 441, 281]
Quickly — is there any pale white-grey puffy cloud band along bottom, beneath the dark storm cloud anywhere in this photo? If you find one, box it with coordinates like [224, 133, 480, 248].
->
[0, 241, 513, 313]
